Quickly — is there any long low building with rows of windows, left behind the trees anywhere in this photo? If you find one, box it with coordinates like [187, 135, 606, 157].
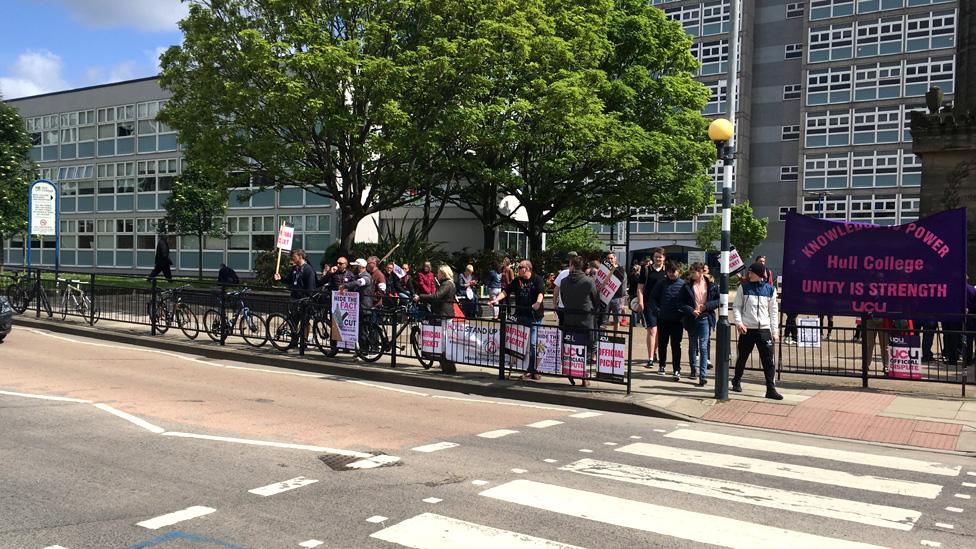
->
[5, 78, 338, 274]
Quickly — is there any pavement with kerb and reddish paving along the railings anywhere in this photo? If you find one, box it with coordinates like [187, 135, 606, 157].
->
[9, 316, 976, 454]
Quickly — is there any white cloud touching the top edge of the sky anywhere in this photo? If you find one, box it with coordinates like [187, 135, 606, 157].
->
[51, 0, 190, 32]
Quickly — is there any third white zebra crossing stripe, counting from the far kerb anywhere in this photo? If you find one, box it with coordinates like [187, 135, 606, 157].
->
[560, 459, 922, 531]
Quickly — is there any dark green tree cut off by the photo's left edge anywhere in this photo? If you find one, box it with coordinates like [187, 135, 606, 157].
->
[0, 98, 36, 263]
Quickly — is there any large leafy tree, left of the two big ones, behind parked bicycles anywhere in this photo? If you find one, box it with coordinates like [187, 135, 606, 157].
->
[160, 0, 482, 253]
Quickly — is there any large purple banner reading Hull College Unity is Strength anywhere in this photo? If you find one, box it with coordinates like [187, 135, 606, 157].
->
[782, 208, 966, 318]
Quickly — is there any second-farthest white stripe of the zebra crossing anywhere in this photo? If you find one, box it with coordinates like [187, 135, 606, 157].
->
[615, 442, 942, 499]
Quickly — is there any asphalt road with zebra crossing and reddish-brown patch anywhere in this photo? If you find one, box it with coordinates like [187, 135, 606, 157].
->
[0, 329, 976, 549]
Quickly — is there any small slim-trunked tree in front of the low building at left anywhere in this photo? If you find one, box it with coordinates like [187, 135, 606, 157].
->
[162, 168, 233, 280]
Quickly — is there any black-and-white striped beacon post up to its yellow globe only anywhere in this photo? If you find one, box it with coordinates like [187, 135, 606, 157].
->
[708, 118, 735, 400]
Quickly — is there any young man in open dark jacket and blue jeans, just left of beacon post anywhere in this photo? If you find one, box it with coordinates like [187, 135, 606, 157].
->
[681, 262, 719, 387]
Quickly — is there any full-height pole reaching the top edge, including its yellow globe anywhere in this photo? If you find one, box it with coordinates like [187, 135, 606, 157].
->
[708, 0, 739, 401]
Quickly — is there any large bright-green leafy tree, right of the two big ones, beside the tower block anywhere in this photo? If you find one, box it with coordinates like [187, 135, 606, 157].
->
[443, 0, 715, 254]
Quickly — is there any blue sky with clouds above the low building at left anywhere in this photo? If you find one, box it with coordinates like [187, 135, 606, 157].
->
[0, 0, 187, 99]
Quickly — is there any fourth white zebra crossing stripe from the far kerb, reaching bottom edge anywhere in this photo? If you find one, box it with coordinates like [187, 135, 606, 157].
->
[481, 480, 876, 549]
